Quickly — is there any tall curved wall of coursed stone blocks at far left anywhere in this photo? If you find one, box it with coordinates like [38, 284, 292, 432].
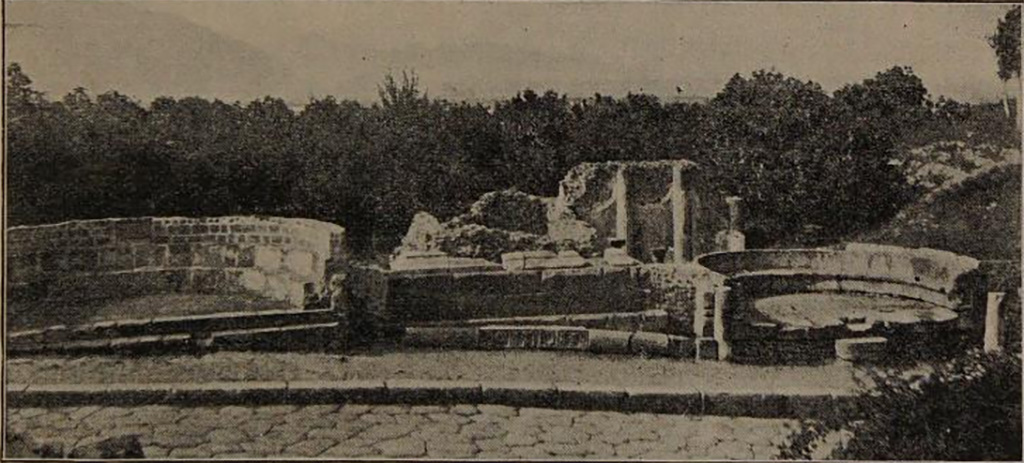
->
[6, 216, 344, 307]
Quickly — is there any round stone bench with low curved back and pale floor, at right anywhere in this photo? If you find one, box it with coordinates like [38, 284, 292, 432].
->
[698, 243, 979, 356]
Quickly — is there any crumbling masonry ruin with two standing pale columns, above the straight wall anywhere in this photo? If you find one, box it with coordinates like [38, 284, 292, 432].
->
[391, 160, 743, 270]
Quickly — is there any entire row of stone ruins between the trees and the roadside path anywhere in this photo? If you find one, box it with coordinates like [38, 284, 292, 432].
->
[7, 161, 1020, 363]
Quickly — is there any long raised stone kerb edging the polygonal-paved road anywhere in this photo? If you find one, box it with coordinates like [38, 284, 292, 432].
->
[6, 379, 860, 419]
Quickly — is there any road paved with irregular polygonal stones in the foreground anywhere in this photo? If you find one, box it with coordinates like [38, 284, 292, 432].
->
[8, 405, 796, 460]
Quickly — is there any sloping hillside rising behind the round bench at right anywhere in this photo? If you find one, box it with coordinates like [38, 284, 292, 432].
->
[854, 159, 1021, 260]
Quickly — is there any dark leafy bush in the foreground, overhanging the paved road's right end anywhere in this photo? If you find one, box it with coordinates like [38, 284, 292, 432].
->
[780, 352, 1021, 461]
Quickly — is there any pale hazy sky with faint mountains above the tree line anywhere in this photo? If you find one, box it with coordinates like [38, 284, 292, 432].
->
[5, 0, 1010, 104]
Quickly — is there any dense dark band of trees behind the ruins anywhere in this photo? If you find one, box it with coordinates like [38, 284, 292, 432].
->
[7, 65, 1018, 254]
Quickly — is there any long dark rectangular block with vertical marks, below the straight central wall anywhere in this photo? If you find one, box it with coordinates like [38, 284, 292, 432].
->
[477, 326, 590, 350]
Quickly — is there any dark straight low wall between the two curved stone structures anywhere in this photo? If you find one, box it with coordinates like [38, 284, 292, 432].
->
[379, 260, 714, 329]
